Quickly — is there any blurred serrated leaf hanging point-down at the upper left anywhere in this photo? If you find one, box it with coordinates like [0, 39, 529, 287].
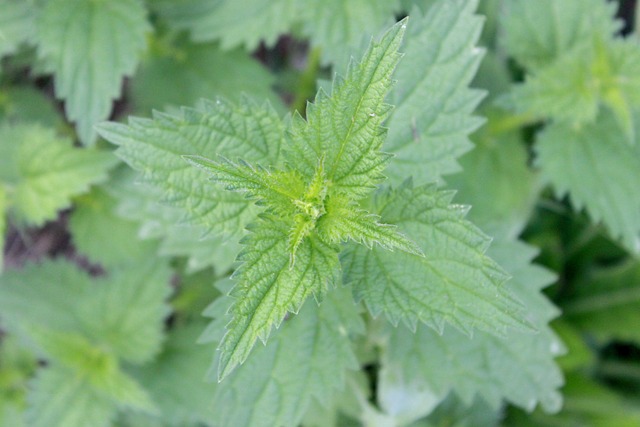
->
[37, 0, 150, 145]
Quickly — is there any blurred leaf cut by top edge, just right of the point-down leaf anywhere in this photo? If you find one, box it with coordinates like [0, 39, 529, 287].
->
[153, 0, 299, 51]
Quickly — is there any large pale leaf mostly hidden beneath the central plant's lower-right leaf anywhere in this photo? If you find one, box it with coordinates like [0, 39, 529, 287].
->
[380, 241, 563, 412]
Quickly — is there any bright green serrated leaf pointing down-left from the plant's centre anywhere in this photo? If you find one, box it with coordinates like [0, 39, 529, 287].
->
[218, 216, 339, 380]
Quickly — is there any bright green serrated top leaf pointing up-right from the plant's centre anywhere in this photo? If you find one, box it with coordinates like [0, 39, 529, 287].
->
[285, 20, 407, 199]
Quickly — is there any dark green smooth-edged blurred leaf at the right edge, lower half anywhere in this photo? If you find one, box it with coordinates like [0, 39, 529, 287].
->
[562, 260, 640, 342]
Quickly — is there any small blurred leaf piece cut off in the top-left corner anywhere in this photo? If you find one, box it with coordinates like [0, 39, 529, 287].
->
[0, 0, 36, 58]
